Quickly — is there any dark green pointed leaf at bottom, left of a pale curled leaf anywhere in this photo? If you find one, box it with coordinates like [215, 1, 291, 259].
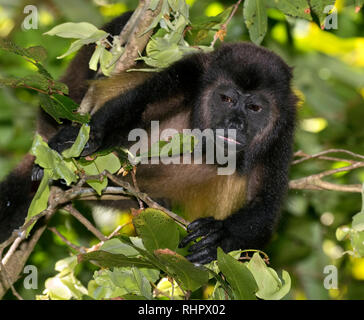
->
[217, 248, 258, 300]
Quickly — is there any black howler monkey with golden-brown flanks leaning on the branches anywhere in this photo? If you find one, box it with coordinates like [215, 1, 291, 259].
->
[0, 11, 296, 263]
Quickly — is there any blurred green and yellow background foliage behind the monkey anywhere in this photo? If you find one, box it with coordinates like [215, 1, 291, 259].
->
[0, 0, 364, 299]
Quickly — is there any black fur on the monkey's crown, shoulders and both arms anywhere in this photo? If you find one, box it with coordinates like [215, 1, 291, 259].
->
[50, 43, 296, 263]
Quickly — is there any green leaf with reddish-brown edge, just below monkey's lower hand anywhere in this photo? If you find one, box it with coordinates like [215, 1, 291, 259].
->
[154, 249, 209, 291]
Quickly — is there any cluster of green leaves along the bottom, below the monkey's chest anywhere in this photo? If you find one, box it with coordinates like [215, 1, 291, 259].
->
[38, 209, 290, 300]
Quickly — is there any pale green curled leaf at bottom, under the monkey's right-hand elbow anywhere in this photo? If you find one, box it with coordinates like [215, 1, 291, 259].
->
[247, 253, 291, 300]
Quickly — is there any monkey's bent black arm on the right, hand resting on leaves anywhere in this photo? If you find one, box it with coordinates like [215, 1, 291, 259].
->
[180, 136, 291, 264]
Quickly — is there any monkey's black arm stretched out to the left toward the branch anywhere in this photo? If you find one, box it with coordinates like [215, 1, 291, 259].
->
[49, 54, 203, 156]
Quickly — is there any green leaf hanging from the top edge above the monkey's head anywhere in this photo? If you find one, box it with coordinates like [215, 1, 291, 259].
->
[244, 0, 268, 44]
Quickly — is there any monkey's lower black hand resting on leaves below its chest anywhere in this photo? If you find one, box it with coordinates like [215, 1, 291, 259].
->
[179, 217, 233, 264]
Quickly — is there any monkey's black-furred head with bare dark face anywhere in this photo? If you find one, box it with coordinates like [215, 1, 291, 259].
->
[194, 43, 296, 161]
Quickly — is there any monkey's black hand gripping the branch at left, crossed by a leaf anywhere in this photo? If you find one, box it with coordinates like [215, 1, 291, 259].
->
[31, 125, 102, 181]
